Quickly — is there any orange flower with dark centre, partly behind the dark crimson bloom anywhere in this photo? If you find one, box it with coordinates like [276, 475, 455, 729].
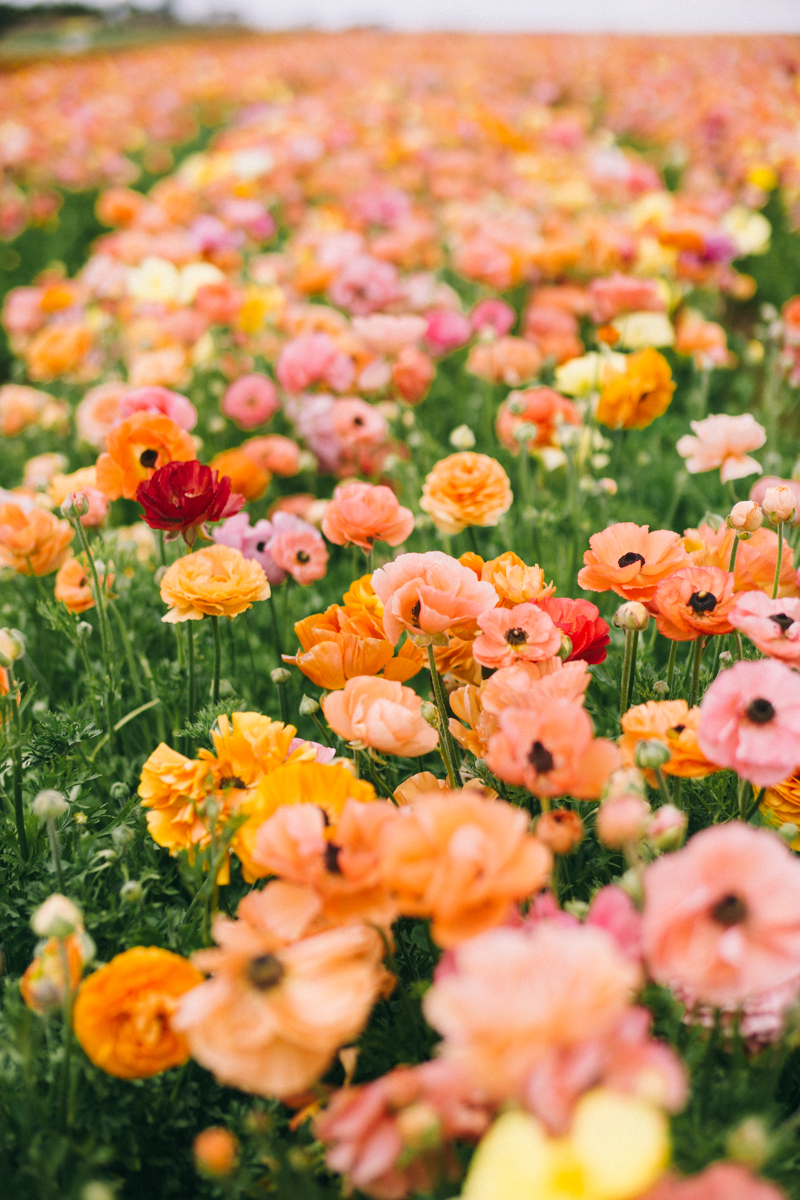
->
[97, 413, 196, 500]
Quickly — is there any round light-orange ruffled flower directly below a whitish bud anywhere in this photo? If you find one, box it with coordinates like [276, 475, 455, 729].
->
[420, 450, 513, 534]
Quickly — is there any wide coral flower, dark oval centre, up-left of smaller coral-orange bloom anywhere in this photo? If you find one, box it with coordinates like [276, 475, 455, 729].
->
[578, 521, 688, 604]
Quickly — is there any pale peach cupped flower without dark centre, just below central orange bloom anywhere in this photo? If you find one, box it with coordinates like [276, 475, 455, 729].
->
[321, 676, 439, 758]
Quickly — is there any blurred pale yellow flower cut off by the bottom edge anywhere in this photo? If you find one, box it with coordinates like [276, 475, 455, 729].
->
[462, 1087, 669, 1200]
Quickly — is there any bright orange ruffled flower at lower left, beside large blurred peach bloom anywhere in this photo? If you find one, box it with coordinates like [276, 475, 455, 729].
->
[72, 946, 203, 1079]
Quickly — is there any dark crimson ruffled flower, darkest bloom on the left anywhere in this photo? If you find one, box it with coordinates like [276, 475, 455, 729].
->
[136, 458, 245, 546]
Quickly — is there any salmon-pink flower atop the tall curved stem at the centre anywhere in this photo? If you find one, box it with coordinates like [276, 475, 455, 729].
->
[372, 550, 498, 646]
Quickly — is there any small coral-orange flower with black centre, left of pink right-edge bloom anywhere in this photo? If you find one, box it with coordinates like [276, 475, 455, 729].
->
[652, 566, 735, 642]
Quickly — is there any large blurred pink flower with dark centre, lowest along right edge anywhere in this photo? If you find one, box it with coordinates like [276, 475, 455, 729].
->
[643, 821, 800, 1007]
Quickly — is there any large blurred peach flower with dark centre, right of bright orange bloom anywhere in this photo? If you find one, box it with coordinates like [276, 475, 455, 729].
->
[174, 881, 390, 1097]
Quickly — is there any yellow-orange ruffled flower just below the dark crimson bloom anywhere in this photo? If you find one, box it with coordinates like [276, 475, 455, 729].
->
[161, 546, 270, 624]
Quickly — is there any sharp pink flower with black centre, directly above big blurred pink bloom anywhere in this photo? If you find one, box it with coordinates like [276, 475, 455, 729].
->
[697, 659, 800, 787]
